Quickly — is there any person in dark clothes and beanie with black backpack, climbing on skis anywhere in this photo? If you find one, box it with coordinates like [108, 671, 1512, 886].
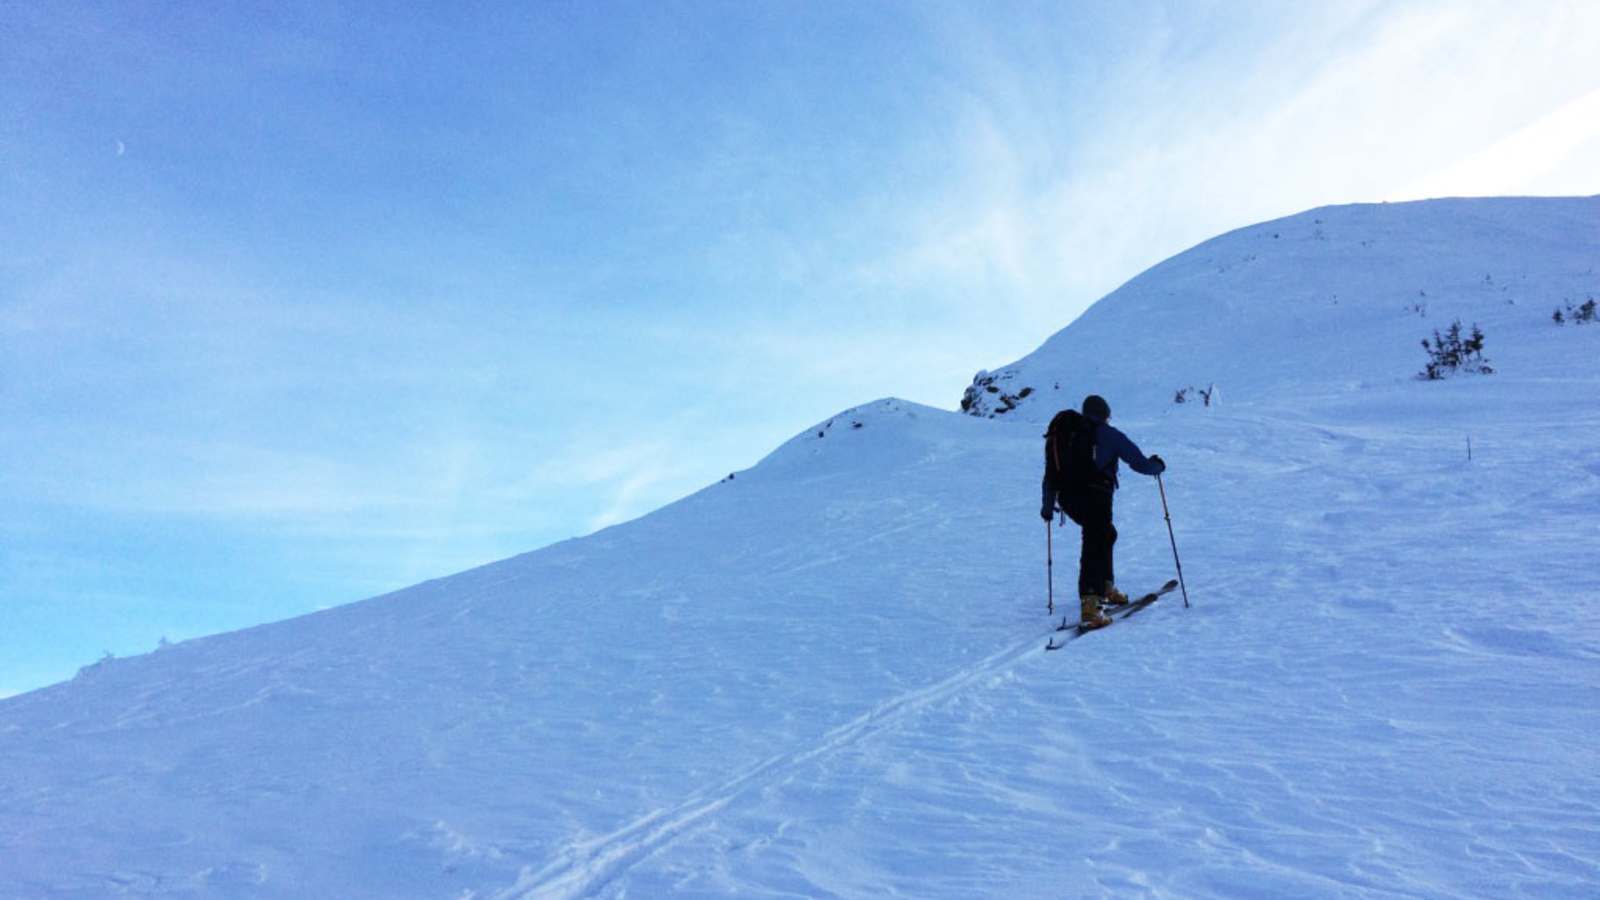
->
[1038, 394, 1166, 631]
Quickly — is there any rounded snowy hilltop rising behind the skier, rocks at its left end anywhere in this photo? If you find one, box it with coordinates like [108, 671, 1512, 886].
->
[963, 197, 1600, 421]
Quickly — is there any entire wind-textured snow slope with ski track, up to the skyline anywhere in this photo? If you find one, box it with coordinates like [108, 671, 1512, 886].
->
[0, 199, 1600, 898]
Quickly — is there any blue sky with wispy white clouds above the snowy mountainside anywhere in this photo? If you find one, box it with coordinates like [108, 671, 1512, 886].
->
[0, 0, 1600, 695]
